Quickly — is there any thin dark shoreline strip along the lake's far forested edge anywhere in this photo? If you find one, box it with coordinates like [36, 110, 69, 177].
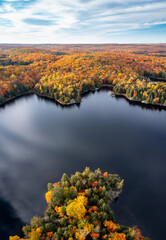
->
[0, 84, 166, 110]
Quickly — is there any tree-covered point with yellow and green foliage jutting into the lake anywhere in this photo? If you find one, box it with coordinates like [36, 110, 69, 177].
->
[9, 167, 148, 240]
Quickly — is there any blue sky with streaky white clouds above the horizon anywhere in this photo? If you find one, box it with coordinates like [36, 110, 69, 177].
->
[0, 0, 166, 43]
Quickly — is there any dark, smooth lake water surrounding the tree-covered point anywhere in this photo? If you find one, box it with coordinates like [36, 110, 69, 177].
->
[0, 90, 166, 240]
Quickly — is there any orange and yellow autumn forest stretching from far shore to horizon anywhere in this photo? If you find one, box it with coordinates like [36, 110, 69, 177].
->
[0, 44, 166, 106]
